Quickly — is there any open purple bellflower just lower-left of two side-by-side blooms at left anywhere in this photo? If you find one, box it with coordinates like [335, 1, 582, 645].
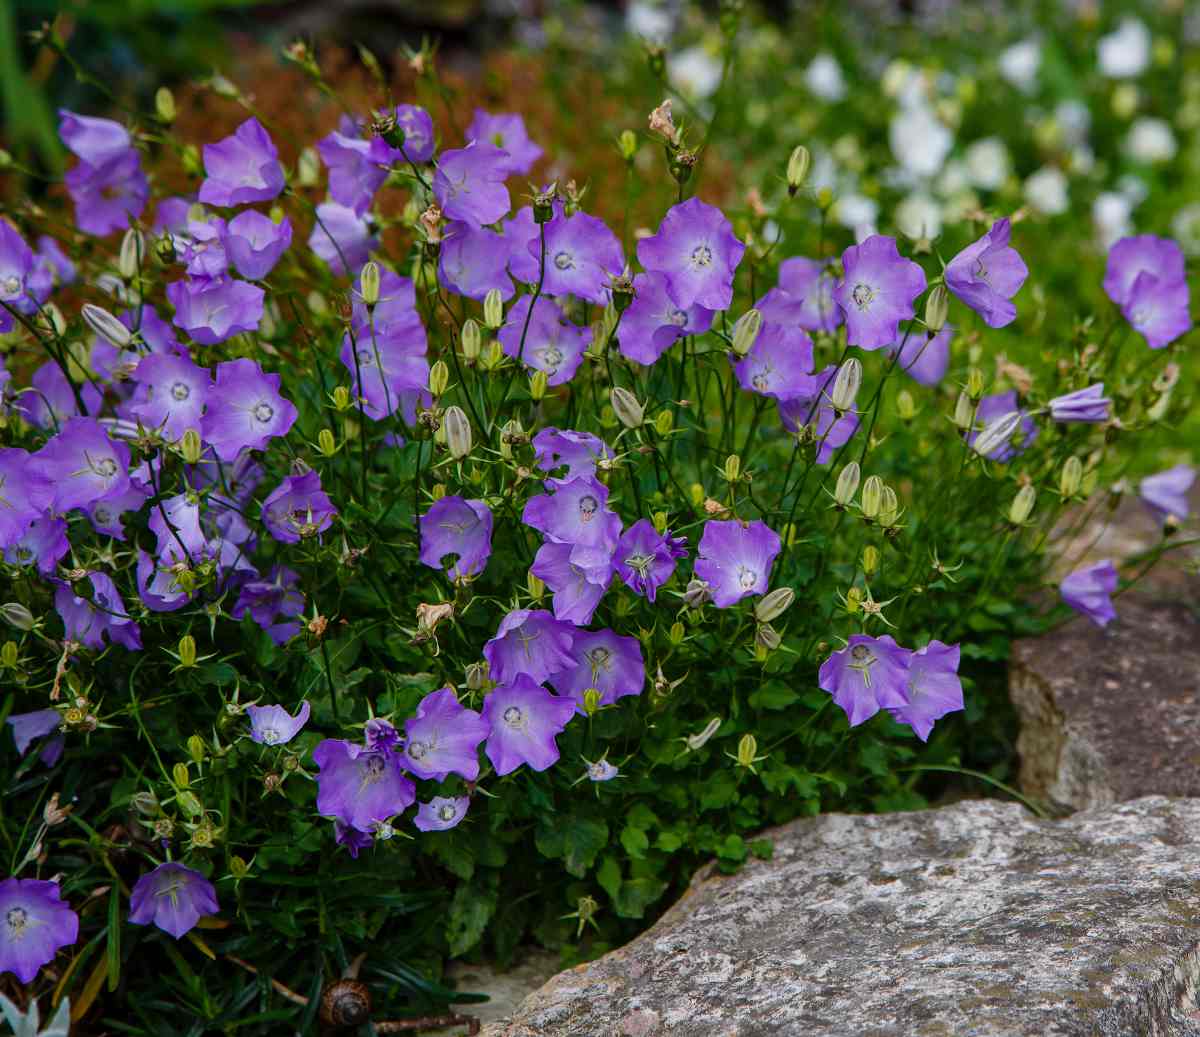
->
[32, 418, 130, 511]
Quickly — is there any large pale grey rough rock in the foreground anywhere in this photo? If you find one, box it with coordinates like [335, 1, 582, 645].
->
[484, 797, 1200, 1037]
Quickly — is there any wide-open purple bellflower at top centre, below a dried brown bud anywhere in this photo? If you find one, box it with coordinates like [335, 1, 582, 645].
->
[637, 198, 746, 310]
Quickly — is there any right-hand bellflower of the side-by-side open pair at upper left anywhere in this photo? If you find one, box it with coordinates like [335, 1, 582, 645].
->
[202, 358, 296, 461]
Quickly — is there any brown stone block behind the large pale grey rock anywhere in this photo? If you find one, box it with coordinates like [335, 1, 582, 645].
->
[1009, 593, 1200, 810]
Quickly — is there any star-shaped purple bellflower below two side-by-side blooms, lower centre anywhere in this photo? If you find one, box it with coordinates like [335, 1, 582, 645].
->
[484, 671, 575, 777]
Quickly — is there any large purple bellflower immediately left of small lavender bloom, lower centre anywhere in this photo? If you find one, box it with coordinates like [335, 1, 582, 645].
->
[312, 738, 416, 832]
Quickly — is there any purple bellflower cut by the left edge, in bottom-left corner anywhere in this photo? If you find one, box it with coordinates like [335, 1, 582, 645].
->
[0, 879, 79, 983]
